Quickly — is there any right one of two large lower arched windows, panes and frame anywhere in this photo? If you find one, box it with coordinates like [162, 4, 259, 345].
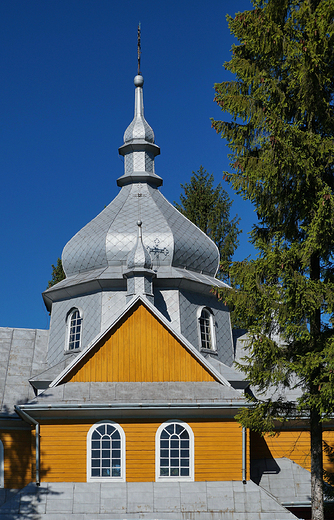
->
[155, 420, 194, 482]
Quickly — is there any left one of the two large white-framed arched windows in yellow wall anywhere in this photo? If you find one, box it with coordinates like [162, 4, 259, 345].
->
[87, 421, 125, 482]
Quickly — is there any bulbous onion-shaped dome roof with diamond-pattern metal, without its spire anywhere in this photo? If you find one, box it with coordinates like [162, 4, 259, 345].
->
[63, 183, 219, 276]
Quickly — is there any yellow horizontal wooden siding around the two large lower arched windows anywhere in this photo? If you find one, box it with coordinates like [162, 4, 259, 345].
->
[41, 420, 245, 482]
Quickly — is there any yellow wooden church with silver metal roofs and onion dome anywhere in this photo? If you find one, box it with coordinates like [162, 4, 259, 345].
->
[0, 63, 334, 520]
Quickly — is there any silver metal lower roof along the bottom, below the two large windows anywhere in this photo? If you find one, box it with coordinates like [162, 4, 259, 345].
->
[0, 481, 297, 520]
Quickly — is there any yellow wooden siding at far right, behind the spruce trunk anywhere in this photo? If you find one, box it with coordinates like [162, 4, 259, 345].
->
[251, 430, 334, 471]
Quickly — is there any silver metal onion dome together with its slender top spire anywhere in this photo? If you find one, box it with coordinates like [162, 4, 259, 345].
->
[62, 76, 219, 277]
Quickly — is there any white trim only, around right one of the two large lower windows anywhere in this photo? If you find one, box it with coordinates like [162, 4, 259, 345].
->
[155, 419, 195, 482]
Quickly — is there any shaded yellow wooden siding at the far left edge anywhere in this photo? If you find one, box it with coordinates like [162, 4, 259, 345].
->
[0, 430, 34, 489]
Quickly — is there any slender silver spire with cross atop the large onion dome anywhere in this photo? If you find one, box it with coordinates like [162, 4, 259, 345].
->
[117, 24, 162, 187]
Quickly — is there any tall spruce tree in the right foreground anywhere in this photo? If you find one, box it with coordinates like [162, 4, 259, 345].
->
[212, 0, 334, 520]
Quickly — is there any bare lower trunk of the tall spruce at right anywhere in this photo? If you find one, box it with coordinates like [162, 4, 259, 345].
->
[310, 410, 324, 520]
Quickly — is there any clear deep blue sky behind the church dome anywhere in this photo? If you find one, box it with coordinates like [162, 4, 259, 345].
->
[0, 0, 255, 328]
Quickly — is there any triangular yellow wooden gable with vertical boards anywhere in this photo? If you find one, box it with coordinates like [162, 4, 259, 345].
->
[66, 304, 215, 382]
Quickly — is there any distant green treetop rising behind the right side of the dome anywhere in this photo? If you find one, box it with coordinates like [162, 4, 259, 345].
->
[174, 166, 241, 278]
